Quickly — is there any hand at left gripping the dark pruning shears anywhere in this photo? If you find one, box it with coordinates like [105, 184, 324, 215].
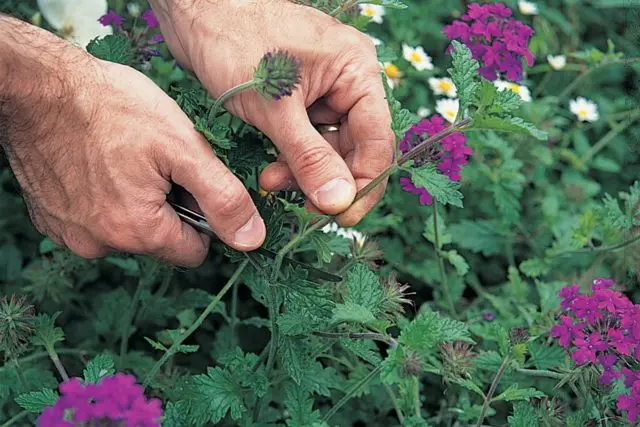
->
[0, 22, 266, 266]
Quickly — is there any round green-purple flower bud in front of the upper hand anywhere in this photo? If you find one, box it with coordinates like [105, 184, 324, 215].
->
[253, 50, 302, 101]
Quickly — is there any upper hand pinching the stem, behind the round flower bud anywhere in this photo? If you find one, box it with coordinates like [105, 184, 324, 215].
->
[151, 0, 394, 226]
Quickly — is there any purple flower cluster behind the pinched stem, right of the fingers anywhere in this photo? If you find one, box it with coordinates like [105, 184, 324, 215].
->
[400, 114, 473, 205]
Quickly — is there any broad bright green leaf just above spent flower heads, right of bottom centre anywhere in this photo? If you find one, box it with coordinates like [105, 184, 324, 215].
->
[398, 312, 473, 352]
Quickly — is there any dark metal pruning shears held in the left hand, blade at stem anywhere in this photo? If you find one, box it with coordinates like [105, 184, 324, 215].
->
[167, 190, 342, 283]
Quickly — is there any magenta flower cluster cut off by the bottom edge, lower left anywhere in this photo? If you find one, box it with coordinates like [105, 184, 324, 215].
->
[38, 373, 162, 427]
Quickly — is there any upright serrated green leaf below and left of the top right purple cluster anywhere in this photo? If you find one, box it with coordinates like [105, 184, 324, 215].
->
[447, 40, 480, 117]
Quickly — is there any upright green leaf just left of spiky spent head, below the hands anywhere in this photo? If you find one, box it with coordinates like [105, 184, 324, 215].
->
[344, 264, 383, 316]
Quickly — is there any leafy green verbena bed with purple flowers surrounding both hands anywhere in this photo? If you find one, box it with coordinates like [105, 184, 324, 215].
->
[0, 0, 640, 427]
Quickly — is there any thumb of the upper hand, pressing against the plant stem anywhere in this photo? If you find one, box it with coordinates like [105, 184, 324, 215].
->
[254, 97, 356, 215]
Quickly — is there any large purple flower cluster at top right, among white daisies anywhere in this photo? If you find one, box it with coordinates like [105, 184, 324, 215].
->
[442, 3, 534, 81]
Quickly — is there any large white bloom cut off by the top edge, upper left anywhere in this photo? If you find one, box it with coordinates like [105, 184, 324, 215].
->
[38, 0, 113, 49]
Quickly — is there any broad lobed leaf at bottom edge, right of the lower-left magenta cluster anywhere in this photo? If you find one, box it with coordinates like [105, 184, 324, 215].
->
[191, 368, 246, 424]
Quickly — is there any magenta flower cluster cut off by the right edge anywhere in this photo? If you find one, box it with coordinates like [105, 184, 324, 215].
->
[551, 279, 640, 422]
